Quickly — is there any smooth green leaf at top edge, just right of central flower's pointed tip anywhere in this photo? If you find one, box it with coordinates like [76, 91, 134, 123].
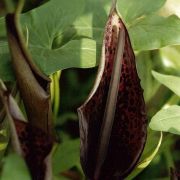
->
[117, 0, 166, 24]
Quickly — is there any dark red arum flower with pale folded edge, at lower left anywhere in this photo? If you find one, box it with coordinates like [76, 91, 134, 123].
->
[0, 80, 53, 180]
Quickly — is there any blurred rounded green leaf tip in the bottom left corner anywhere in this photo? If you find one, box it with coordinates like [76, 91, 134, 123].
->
[1, 154, 31, 180]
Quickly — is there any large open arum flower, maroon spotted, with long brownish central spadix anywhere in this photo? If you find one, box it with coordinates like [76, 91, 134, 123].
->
[78, 1, 147, 180]
